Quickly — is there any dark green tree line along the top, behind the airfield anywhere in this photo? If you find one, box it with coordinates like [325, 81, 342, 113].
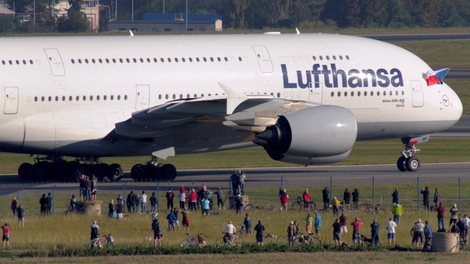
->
[0, 0, 470, 32]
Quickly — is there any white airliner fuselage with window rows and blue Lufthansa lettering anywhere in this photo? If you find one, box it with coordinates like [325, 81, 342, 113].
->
[0, 34, 462, 157]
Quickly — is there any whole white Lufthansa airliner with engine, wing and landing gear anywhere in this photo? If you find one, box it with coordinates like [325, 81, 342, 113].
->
[0, 32, 462, 181]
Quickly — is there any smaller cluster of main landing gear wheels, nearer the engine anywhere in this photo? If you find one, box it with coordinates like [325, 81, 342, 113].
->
[131, 157, 176, 182]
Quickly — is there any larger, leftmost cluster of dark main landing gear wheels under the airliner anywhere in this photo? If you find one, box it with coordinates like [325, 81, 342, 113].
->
[18, 156, 124, 181]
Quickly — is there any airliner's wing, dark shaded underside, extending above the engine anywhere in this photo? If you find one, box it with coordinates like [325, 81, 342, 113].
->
[115, 83, 316, 138]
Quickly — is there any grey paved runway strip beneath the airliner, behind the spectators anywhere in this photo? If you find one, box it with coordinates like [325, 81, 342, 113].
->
[0, 163, 470, 195]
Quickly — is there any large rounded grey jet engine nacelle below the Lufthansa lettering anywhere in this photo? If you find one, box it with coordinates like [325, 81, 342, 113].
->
[253, 105, 357, 160]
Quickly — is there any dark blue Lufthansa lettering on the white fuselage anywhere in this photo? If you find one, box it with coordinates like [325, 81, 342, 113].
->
[281, 63, 403, 89]
